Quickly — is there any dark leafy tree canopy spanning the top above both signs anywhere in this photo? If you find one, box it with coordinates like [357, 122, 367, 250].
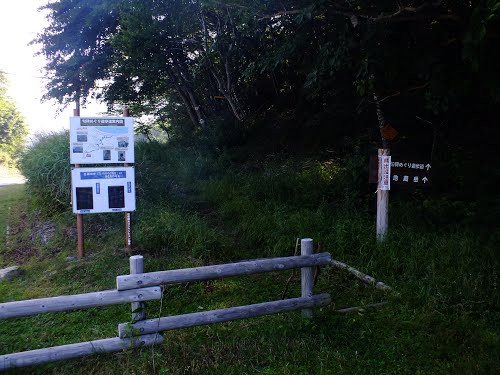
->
[33, 0, 500, 157]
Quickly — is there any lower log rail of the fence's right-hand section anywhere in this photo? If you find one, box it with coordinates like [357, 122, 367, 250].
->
[118, 293, 331, 338]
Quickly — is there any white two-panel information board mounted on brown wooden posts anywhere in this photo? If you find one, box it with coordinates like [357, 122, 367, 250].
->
[70, 107, 135, 258]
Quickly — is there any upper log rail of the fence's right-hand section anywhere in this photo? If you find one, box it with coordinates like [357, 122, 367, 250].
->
[116, 253, 332, 290]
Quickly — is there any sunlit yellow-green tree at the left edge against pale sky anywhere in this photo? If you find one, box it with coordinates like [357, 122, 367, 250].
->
[0, 71, 28, 164]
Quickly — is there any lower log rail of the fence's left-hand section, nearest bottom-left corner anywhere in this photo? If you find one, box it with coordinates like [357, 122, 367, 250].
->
[0, 334, 163, 371]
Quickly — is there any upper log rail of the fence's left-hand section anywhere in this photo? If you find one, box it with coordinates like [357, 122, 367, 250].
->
[0, 287, 161, 319]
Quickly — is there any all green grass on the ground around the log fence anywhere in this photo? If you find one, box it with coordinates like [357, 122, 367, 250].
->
[0, 142, 500, 374]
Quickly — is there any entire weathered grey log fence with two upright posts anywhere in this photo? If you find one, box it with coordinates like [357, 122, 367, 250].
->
[0, 238, 331, 371]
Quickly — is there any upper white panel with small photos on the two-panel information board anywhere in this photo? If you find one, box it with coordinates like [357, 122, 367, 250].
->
[69, 117, 135, 164]
